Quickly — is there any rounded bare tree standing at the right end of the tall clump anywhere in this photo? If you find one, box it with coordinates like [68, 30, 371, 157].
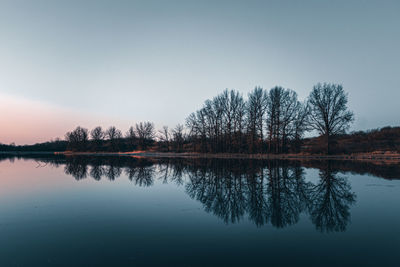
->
[308, 83, 354, 154]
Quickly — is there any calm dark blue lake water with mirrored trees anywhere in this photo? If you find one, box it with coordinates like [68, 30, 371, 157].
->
[0, 156, 400, 266]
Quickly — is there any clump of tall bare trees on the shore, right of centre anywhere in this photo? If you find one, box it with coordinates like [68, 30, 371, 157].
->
[186, 83, 354, 153]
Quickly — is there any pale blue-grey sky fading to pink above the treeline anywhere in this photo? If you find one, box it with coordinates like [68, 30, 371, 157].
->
[0, 0, 400, 144]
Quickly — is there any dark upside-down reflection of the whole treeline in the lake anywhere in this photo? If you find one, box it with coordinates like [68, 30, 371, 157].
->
[28, 156, 356, 232]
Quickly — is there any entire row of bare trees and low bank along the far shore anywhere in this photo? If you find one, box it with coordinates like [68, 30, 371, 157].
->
[0, 83, 400, 154]
